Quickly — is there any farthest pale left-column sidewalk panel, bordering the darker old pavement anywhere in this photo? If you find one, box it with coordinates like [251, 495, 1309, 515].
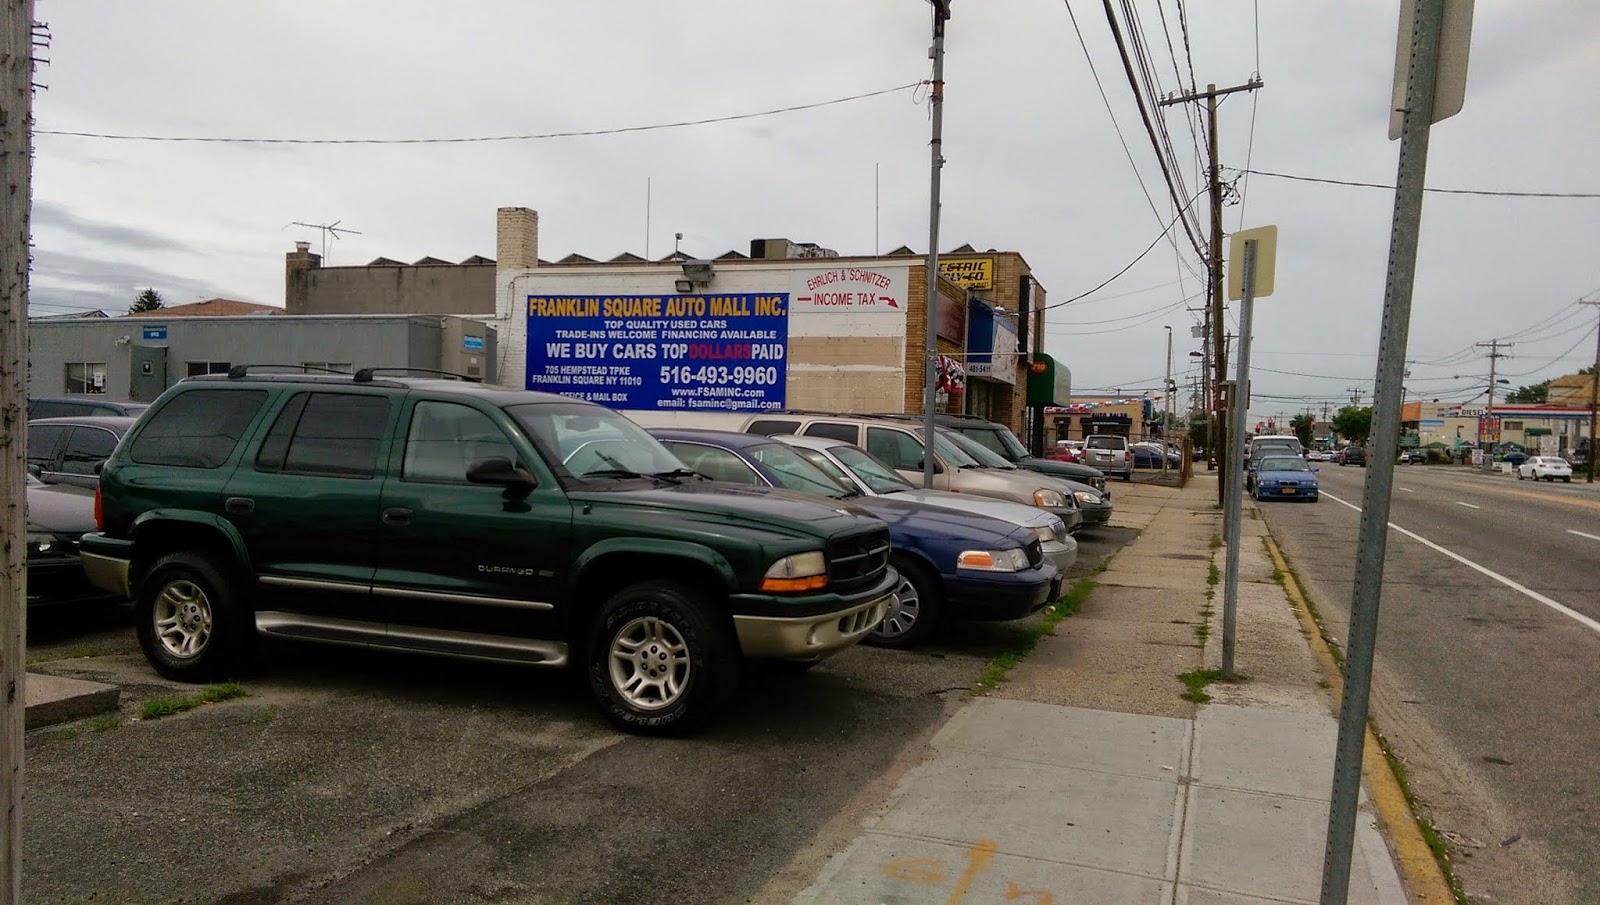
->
[933, 697, 1189, 782]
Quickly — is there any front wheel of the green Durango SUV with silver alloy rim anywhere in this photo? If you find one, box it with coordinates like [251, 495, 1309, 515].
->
[587, 582, 739, 736]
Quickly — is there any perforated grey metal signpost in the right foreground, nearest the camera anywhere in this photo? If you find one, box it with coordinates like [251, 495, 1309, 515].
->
[1322, 0, 1445, 905]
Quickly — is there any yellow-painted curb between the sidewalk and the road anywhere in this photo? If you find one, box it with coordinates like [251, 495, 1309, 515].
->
[1262, 536, 1456, 902]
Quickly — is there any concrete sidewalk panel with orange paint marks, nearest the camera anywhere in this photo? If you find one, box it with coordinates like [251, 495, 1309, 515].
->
[794, 833, 1171, 905]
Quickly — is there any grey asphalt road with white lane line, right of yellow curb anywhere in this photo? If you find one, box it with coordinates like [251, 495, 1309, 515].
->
[1261, 462, 1600, 902]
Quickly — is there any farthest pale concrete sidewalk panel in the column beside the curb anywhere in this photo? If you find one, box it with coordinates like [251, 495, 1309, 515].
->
[1190, 704, 1339, 801]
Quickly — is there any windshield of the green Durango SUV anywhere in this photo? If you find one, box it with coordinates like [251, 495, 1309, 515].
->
[506, 403, 685, 480]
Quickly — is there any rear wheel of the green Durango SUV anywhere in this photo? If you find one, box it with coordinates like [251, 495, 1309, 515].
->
[134, 553, 256, 683]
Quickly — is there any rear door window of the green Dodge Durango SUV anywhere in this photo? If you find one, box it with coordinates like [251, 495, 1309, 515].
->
[256, 393, 389, 478]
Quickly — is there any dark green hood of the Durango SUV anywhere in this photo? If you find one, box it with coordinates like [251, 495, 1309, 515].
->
[568, 481, 872, 539]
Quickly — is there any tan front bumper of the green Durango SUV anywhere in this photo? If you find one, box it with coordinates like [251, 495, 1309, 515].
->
[733, 568, 899, 660]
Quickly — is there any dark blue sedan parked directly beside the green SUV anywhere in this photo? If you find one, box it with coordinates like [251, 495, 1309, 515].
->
[651, 427, 1062, 648]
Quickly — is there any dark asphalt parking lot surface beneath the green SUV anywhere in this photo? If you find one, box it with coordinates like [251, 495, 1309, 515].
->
[24, 528, 1133, 905]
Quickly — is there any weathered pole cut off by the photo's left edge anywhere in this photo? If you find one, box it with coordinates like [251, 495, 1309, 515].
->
[0, 0, 34, 905]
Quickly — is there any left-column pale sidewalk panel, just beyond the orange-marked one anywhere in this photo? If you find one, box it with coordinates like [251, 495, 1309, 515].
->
[874, 750, 1181, 879]
